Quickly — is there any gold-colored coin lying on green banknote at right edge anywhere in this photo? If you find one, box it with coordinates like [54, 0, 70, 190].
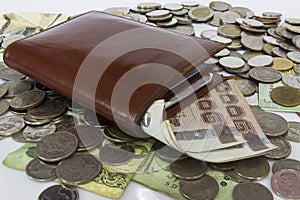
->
[271, 86, 300, 106]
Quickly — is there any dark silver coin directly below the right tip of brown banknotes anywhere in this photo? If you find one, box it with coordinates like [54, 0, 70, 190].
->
[234, 157, 270, 180]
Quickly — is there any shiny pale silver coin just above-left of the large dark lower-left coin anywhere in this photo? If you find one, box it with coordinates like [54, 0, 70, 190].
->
[23, 123, 56, 142]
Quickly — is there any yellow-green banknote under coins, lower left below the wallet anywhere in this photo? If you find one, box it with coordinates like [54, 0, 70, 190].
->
[3, 140, 153, 199]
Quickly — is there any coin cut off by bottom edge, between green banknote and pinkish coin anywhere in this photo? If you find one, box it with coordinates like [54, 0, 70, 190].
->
[232, 182, 274, 200]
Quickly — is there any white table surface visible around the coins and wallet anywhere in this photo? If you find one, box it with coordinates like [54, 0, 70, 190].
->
[0, 0, 300, 200]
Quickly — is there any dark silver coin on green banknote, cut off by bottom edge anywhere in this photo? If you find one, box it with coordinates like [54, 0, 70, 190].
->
[179, 175, 219, 200]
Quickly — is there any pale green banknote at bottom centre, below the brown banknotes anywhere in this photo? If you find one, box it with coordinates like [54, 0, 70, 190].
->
[133, 153, 238, 200]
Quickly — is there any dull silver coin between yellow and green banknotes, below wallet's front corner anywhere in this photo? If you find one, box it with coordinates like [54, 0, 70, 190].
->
[99, 144, 135, 166]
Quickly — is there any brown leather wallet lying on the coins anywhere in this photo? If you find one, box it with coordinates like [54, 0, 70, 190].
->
[4, 11, 224, 136]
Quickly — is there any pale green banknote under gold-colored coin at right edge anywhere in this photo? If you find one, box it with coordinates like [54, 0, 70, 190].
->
[258, 70, 300, 112]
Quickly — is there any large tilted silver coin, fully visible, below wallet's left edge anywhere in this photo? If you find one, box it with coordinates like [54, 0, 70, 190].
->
[10, 90, 46, 110]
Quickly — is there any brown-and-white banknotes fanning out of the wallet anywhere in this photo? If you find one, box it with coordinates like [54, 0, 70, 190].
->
[143, 80, 276, 163]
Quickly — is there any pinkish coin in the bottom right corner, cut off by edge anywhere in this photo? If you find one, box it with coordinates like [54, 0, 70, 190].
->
[271, 169, 300, 199]
